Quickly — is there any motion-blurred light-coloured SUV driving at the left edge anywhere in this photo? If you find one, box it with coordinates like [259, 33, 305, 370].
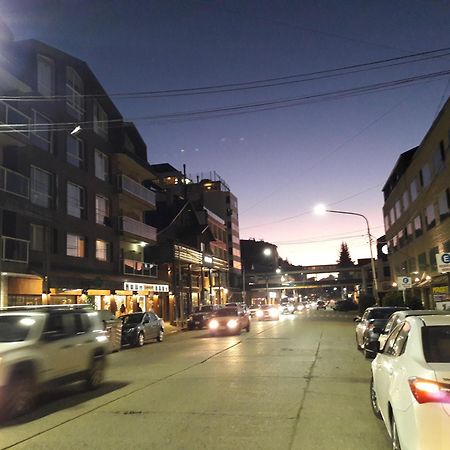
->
[0, 306, 109, 419]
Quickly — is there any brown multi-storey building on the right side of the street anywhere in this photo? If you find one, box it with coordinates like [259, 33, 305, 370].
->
[383, 94, 450, 307]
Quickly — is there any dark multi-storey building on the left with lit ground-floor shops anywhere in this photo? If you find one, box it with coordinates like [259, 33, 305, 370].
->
[0, 24, 168, 311]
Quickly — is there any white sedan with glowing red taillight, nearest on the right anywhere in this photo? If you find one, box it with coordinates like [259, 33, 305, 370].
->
[370, 315, 450, 450]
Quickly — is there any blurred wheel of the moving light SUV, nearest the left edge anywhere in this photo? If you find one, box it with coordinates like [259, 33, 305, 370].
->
[0, 375, 35, 420]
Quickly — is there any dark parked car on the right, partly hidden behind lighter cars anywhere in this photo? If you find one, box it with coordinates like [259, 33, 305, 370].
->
[355, 306, 409, 358]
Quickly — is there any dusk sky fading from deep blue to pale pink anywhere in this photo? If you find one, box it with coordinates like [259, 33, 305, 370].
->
[0, 0, 450, 265]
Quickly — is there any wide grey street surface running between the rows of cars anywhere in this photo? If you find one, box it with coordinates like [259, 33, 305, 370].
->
[0, 311, 390, 450]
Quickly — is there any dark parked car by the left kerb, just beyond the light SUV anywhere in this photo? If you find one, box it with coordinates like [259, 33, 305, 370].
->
[121, 311, 164, 347]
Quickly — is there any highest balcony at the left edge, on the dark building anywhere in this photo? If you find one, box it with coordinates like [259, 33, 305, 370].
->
[0, 102, 31, 146]
